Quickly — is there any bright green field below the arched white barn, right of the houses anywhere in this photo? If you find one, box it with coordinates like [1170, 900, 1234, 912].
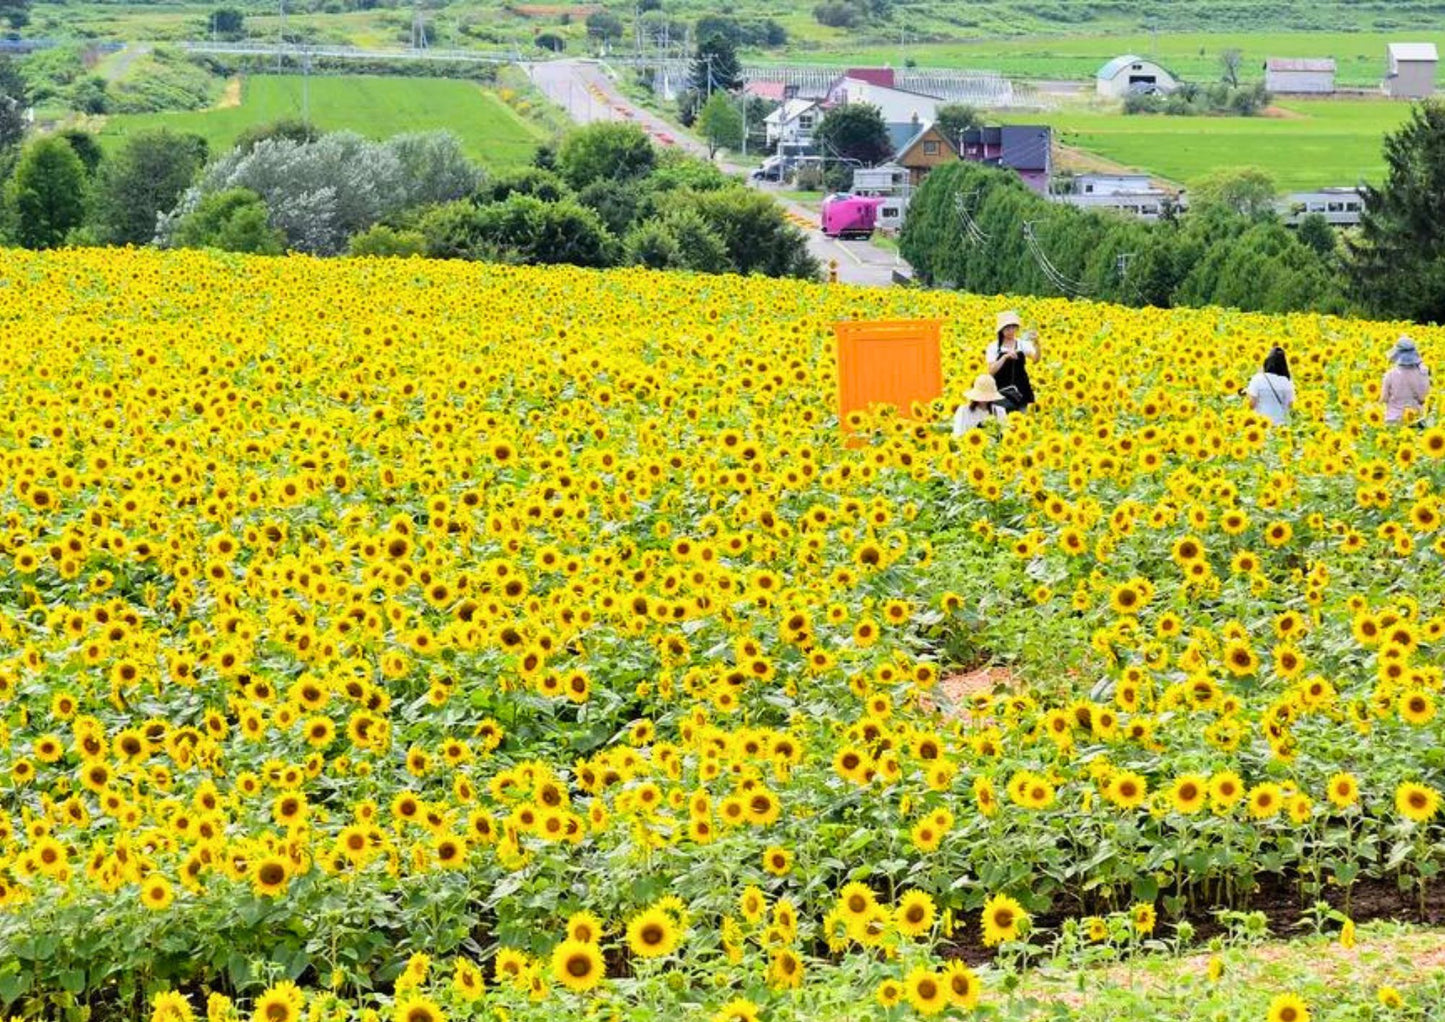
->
[1042, 100, 1410, 189]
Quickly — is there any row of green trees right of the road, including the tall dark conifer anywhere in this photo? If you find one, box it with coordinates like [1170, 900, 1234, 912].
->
[899, 103, 1445, 322]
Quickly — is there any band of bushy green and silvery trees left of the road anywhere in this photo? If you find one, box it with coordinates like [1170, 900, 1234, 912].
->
[0, 61, 821, 279]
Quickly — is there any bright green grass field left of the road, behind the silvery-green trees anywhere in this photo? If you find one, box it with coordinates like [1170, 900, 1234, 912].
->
[101, 75, 546, 169]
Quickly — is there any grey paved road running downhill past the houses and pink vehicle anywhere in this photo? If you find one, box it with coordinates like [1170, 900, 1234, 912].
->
[523, 61, 907, 288]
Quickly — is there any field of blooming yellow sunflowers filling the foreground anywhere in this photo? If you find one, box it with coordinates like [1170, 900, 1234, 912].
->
[0, 250, 1445, 1022]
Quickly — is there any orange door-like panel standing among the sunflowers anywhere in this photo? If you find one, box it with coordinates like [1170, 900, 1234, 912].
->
[832, 319, 944, 430]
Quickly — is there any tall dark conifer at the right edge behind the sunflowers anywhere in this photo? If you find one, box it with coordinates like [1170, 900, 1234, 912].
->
[1347, 103, 1445, 322]
